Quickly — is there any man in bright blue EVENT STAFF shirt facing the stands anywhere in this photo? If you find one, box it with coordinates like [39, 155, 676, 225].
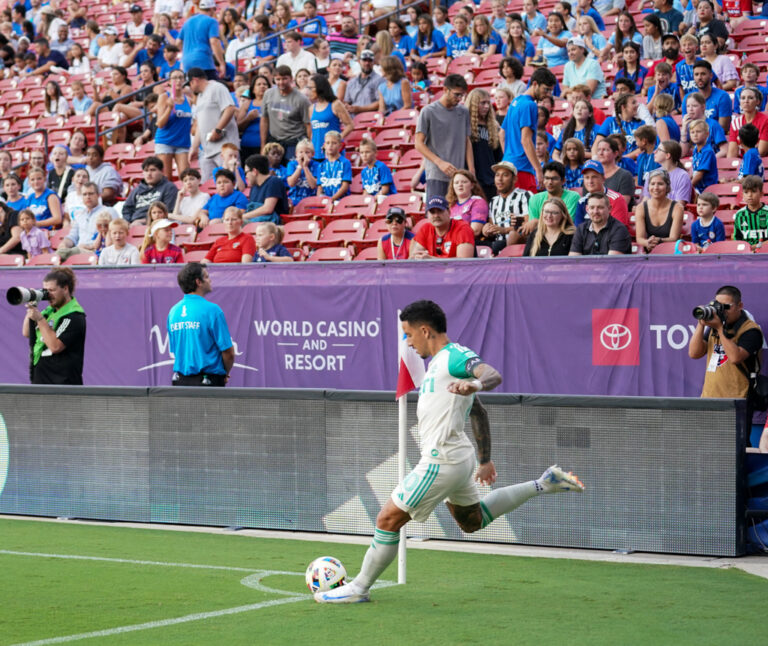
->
[168, 262, 235, 386]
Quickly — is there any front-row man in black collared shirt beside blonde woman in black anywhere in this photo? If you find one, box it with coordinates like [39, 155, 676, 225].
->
[568, 193, 632, 256]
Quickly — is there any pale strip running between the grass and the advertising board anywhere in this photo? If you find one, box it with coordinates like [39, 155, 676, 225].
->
[0, 514, 768, 579]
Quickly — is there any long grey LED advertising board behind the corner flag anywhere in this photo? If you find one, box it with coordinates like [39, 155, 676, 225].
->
[0, 386, 744, 556]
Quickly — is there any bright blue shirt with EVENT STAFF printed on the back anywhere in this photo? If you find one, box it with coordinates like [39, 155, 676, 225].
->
[167, 294, 232, 375]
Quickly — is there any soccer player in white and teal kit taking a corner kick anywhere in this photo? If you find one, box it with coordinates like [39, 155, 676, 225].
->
[315, 301, 584, 603]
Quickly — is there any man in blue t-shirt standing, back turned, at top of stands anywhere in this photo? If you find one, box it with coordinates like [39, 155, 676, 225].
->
[179, 0, 227, 79]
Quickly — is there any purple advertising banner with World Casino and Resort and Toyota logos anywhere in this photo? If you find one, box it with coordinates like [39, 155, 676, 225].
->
[0, 254, 768, 397]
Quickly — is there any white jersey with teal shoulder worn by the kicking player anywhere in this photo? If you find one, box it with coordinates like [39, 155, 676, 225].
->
[416, 343, 482, 464]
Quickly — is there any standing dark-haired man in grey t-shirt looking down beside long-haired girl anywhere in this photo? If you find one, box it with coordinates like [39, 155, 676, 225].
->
[416, 74, 475, 202]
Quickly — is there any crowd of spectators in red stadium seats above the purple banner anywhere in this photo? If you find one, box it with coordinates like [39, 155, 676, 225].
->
[0, 0, 768, 265]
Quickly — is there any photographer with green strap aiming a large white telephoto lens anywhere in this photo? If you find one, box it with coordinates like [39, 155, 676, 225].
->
[17, 267, 85, 385]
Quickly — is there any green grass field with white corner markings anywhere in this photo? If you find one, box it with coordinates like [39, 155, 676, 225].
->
[0, 520, 768, 646]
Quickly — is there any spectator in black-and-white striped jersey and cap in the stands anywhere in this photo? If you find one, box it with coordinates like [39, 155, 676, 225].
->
[479, 161, 533, 255]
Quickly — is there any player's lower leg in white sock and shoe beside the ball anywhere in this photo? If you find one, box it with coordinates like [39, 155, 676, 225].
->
[315, 500, 411, 603]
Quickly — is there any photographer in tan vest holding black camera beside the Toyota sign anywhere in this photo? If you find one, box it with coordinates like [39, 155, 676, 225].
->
[688, 285, 763, 440]
